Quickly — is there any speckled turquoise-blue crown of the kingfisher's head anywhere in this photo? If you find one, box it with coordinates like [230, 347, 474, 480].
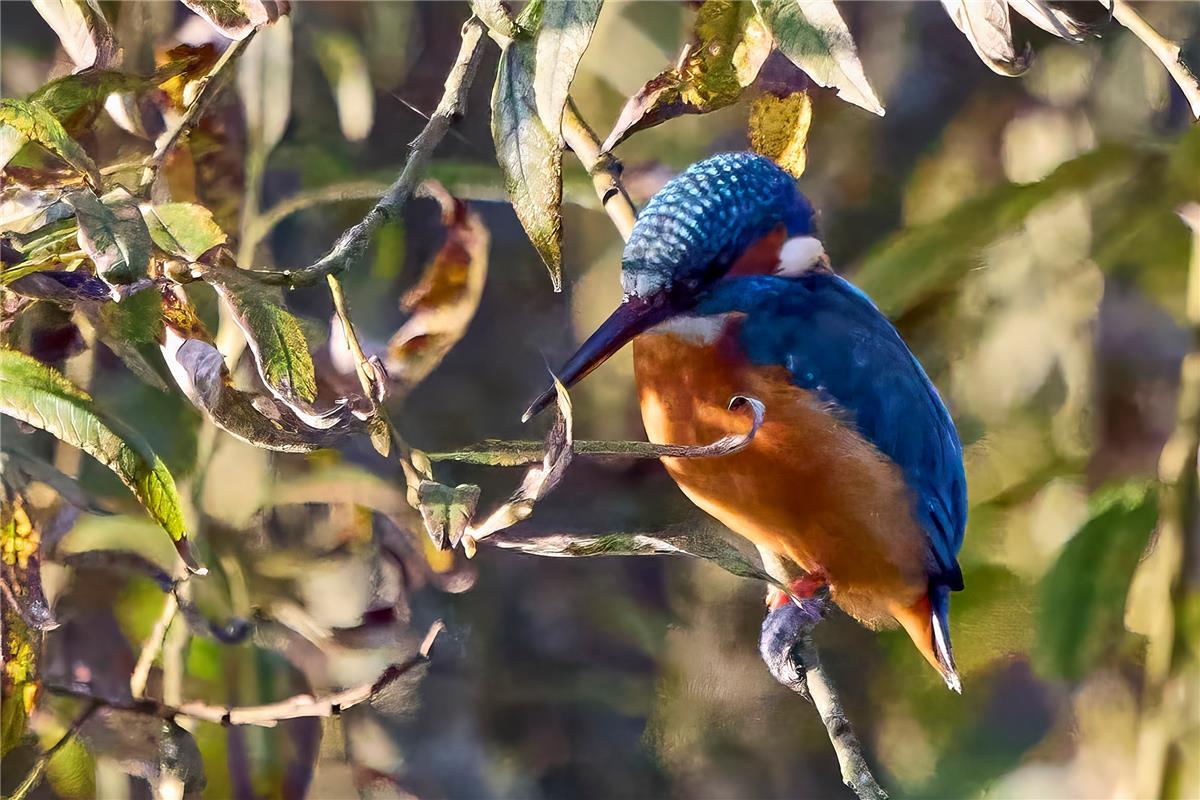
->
[622, 152, 812, 294]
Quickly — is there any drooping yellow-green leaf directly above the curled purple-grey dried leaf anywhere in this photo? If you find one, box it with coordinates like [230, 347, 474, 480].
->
[203, 267, 317, 405]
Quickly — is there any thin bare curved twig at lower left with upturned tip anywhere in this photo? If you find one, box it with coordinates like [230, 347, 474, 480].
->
[47, 620, 445, 728]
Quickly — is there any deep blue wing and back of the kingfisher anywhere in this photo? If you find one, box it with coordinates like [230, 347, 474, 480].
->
[697, 272, 966, 589]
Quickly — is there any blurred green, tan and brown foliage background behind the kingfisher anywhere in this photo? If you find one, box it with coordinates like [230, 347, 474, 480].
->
[0, 0, 1200, 799]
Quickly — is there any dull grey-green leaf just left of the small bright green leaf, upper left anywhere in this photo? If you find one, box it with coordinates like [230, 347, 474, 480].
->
[64, 188, 152, 285]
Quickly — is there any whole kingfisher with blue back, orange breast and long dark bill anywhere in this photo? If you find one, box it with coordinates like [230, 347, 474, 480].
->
[524, 152, 967, 692]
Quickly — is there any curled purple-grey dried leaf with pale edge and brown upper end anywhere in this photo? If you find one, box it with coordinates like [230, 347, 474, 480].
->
[162, 288, 362, 452]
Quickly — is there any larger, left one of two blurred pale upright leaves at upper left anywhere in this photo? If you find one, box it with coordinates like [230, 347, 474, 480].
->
[238, 18, 292, 154]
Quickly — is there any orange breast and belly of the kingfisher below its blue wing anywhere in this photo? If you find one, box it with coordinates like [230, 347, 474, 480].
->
[634, 321, 930, 624]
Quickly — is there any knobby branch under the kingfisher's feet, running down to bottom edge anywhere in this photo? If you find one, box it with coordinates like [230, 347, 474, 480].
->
[758, 596, 888, 800]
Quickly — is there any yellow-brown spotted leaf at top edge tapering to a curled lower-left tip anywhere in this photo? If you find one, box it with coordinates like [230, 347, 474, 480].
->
[604, 0, 772, 150]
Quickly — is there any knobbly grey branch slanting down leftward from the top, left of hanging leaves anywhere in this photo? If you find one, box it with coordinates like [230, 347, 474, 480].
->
[275, 17, 485, 287]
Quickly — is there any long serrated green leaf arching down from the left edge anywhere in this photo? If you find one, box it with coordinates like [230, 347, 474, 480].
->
[0, 348, 198, 570]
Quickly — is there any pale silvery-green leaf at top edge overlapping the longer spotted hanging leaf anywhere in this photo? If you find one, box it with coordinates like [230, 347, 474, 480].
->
[533, 0, 604, 136]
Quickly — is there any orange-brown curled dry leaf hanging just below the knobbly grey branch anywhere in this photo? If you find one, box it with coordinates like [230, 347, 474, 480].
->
[384, 191, 488, 392]
